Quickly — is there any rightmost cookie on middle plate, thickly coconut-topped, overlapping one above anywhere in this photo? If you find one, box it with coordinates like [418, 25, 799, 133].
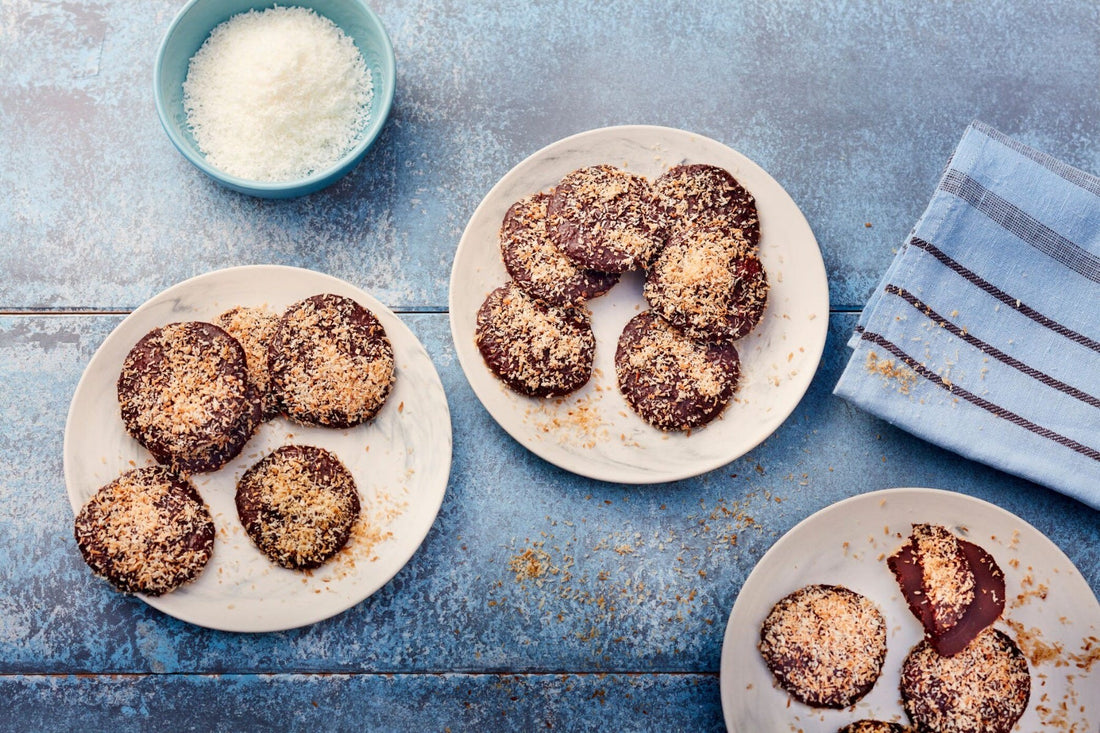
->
[642, 228, 768, 341]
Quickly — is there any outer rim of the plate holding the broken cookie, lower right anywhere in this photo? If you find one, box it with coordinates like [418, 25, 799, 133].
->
[718, 486, 1100, 732]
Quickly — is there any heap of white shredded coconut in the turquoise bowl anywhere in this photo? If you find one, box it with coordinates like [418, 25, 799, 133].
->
[184, 7, 374, 182]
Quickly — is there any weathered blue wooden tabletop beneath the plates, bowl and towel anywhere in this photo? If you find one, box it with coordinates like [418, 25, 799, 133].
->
[0, 0, 1100, 731]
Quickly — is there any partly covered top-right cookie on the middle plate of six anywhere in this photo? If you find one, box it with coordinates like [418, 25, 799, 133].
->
[653, 163, 760, 247]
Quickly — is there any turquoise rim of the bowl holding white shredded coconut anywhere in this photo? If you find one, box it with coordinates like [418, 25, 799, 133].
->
[153, 0, 397, 196]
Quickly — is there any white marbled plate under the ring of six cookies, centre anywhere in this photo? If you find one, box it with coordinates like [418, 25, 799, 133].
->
[450, 125, 828, 483]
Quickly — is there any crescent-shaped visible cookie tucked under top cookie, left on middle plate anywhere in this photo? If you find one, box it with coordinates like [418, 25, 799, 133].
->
[501, 194, 619, 306]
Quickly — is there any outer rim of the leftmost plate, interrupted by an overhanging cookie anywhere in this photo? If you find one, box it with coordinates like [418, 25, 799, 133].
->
[62, 264, 454, 633]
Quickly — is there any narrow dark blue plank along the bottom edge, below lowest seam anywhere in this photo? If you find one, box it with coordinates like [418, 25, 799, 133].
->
[0, 672, 725, 733]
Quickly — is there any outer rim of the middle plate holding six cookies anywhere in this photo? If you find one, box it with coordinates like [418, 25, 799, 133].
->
[448, 124, 829, 485]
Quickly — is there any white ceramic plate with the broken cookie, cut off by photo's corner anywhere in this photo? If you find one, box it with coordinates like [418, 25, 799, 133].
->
[721, 489, 1100, 733]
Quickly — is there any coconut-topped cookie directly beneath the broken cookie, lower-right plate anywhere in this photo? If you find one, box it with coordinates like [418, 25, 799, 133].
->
[901, 628, 1031, 733]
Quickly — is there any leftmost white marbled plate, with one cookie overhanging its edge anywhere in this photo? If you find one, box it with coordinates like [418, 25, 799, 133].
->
[65, 265, 451, 632]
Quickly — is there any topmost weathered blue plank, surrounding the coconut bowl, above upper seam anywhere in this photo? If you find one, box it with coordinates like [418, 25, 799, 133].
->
[0, 0, 1100, 308]
